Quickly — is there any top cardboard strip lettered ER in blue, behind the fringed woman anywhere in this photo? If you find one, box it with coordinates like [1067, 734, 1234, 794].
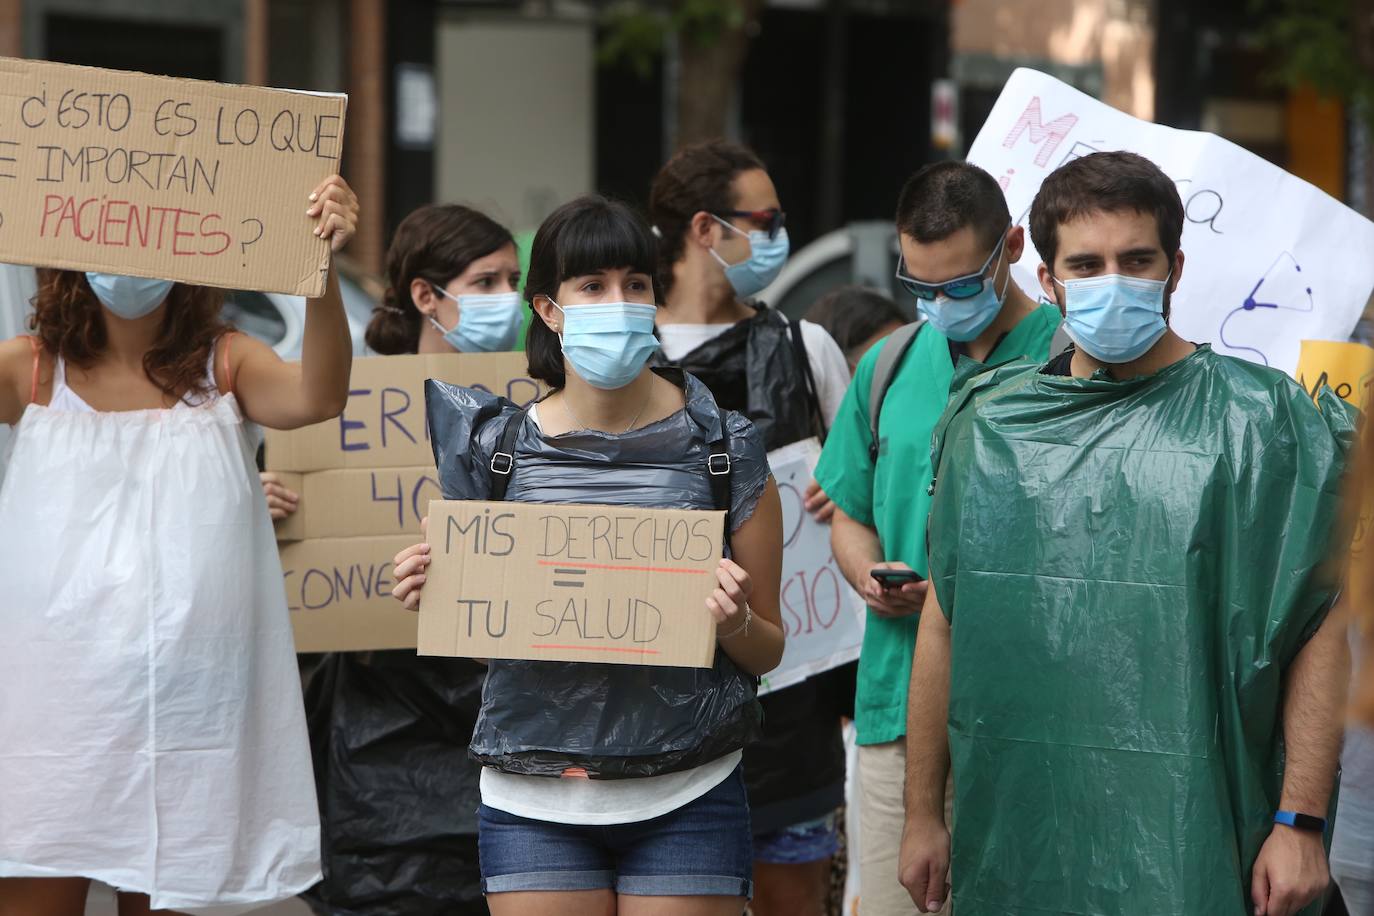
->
[267, 353, 547, 471]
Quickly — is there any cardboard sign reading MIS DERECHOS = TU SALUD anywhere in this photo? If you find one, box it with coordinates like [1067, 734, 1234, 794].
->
[419, 500, 724, 667]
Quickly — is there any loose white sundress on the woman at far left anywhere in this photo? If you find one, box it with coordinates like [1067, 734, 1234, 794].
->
[0, 346, 320, 913]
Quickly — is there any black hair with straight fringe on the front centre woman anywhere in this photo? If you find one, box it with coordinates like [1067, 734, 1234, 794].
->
[525, 194, 658, 389]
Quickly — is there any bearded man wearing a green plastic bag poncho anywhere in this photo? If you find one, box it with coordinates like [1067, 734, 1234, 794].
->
[901, 152, 1353, 916]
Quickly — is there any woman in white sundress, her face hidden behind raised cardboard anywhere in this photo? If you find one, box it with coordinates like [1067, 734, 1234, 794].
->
[0, 176, 357, 916]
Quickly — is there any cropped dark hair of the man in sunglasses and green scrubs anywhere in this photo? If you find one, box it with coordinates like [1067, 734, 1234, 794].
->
[897, 161, 1011, 251]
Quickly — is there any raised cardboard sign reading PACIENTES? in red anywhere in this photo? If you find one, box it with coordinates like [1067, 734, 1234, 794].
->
[0, 58, 348, 297]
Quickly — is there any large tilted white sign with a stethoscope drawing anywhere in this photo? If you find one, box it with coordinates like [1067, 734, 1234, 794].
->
[969, 69, 1374, 374]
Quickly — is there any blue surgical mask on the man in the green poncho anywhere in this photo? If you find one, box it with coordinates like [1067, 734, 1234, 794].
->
[1054, 271, 1173, 364]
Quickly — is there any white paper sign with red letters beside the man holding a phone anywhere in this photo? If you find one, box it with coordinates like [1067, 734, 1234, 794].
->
[758, 438, 864, 694]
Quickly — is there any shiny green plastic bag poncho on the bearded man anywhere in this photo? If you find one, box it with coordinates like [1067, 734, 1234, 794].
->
[929, 346, 1353, 916]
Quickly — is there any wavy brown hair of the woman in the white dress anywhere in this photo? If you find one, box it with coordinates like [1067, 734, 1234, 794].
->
[29, 269, 229, 398]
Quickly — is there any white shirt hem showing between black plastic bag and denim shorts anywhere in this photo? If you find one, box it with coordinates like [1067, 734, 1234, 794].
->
[481, 404, 743, 825]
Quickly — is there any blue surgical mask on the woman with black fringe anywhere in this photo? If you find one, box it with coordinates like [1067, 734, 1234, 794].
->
[550, 299, 658, 390]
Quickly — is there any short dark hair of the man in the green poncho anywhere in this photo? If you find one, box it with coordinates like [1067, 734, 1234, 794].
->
[1031, 152, 1183, 271]
